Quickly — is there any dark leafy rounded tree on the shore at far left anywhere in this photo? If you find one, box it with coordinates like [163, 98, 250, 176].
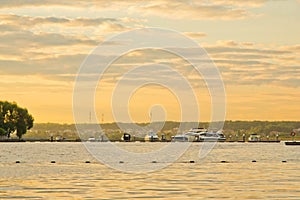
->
[0, 101, 34, 139]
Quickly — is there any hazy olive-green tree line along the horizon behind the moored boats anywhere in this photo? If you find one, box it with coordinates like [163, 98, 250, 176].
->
[29, 121, 300, 140]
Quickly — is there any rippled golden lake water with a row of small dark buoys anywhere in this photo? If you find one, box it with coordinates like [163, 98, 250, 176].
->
[0, 142, 300, 199]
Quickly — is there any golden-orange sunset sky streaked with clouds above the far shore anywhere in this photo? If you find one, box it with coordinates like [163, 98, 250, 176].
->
[0, 0, 300, 123]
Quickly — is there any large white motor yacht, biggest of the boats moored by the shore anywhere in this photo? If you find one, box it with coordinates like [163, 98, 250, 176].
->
[185, 128, 226, 142]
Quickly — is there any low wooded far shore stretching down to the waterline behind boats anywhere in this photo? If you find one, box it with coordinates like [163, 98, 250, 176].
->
[0, 121, 300, 143]
